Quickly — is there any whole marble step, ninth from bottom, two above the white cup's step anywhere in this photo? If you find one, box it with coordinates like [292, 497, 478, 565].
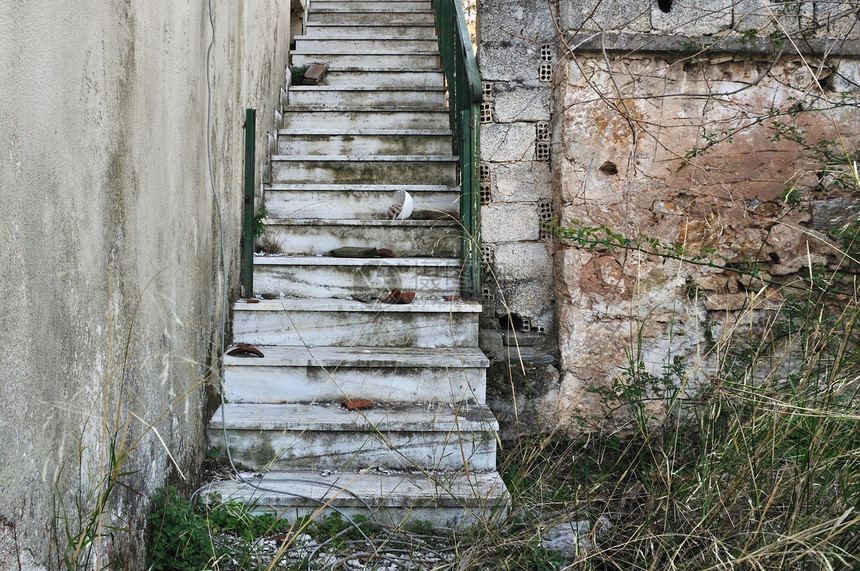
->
[278, 129, 452, 155]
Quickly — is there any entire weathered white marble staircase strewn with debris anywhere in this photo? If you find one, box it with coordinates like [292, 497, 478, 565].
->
[209, 0, 508, 527]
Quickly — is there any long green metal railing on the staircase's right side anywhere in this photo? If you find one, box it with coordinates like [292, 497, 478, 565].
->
[433, 0, 483, 298]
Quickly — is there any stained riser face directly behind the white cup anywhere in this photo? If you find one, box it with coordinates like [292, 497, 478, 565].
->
[266, 190, 460, 220]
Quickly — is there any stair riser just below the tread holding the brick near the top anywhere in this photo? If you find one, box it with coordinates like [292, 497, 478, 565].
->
[289, 89, 445, 109]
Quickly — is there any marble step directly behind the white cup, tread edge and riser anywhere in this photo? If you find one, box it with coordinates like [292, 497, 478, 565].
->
[265, 184, 460, 220]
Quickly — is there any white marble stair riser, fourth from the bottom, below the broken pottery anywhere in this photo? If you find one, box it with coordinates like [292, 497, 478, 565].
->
[233, 308, 478, 347]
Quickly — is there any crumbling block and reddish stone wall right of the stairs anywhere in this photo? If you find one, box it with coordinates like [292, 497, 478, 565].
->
[478, 0, 860, 433]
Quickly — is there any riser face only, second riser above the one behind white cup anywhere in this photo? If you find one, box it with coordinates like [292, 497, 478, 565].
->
[278, 134, 451, 155]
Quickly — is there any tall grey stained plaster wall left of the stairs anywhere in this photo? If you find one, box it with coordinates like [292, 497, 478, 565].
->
[0, 0, 289, 569]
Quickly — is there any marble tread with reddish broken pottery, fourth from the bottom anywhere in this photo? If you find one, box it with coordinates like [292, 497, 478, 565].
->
[233, 298, 481, 314]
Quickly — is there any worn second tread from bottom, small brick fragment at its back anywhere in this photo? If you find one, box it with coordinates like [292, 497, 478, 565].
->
[209, 402, 499, 433]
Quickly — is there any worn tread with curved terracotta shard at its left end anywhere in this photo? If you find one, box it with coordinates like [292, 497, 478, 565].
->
[224, 345, 490, 368]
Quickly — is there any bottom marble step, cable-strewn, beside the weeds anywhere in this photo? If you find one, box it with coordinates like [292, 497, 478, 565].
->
[201, 470, 510, 529]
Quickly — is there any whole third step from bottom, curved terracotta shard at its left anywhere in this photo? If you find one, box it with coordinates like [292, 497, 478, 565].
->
[223, 346, 489, 403]
